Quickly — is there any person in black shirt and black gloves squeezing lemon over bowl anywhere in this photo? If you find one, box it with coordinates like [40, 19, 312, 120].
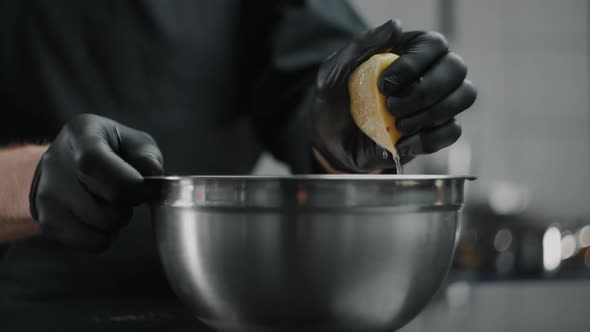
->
[0, 0, 476, 331]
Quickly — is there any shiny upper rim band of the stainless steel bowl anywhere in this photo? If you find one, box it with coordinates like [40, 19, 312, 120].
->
[145, 174, 474, 210]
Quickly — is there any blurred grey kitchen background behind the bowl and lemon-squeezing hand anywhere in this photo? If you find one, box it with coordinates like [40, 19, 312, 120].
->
[256, 0, 590, 332]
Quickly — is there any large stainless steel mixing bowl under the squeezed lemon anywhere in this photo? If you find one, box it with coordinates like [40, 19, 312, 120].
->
[148, 175, 468, 332]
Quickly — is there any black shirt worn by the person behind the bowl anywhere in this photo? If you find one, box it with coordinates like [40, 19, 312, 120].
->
[0, 0, 365, 331]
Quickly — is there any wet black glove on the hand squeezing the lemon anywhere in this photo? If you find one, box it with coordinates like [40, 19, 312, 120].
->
[312, 21, 477, 173]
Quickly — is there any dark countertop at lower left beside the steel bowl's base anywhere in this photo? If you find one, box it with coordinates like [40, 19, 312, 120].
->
[0, 297, 211, 332]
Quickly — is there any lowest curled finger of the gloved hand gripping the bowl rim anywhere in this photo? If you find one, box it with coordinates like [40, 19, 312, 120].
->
[39, 200, 111, 252]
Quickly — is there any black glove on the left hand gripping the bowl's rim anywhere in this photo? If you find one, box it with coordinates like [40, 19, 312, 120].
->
[30, 114, 163, 251]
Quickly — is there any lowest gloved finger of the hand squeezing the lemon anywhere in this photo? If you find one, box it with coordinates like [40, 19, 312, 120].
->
[396, 120, 461, 156]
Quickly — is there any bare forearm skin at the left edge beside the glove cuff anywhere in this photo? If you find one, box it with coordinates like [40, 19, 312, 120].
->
[0, 145, 47, 243]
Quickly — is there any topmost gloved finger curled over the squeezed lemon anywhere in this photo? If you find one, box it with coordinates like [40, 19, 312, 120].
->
[379, 31, 448, 96]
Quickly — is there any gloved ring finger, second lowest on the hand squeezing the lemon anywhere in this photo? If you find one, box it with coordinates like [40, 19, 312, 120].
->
[396, 81, 477, 136]
